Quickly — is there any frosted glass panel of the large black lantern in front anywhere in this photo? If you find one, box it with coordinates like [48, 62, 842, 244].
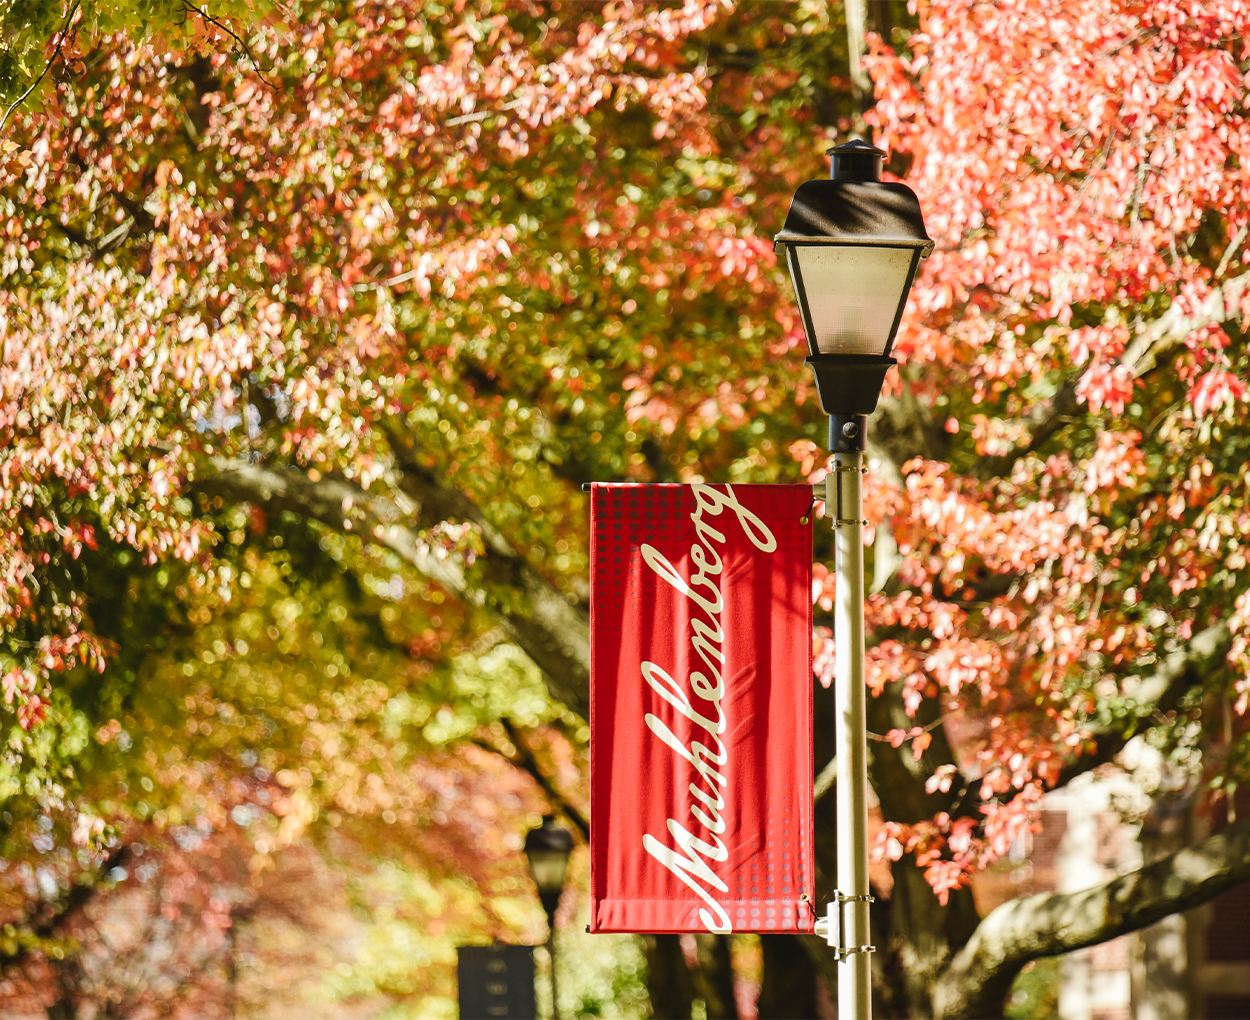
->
[791, 245, 915, 354]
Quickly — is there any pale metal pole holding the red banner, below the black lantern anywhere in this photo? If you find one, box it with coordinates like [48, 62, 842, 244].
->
[825, 440, 873, 1020]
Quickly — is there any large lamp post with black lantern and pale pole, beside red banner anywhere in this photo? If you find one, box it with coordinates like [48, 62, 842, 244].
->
[774, 140, 933, 1020]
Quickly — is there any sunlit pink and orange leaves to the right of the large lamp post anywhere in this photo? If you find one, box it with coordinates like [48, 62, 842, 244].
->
[845, 0, 1250, 889]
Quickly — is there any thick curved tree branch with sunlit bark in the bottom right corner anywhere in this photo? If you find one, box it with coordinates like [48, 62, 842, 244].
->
[934, 820, 1250, 1018]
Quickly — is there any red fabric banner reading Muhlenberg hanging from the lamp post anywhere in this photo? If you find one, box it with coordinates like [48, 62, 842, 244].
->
[590, 484, 815, 933]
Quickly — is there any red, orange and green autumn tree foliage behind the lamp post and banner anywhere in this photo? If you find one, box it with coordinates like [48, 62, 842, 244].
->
[0, 0, 1250, 1015]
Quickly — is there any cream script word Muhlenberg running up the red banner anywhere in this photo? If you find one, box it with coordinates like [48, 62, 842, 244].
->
[643, 485, 778, 935]
